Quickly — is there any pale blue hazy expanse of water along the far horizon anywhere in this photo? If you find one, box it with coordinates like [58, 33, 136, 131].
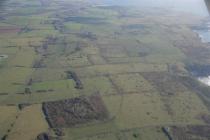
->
[99, 0, 209, 16]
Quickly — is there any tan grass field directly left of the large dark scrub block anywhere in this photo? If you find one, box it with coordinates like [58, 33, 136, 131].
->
[8, 104, 48, 140]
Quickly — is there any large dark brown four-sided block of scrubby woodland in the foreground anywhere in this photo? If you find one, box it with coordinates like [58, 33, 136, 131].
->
[43, 95, 108, 128]
